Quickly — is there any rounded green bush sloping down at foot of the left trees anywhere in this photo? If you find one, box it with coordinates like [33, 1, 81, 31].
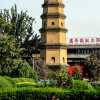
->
[11, 60, 38, 80]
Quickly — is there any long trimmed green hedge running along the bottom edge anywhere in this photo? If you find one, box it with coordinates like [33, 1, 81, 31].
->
[0, 87, 100, 100]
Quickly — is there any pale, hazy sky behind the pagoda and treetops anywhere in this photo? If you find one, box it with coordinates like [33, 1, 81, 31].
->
[0, 0, 100, 37]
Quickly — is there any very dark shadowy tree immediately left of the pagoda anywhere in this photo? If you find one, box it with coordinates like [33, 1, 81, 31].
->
[22, 34, 41, 65]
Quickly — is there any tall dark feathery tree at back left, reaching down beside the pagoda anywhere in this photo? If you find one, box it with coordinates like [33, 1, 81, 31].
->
[0, 5, 40, 64]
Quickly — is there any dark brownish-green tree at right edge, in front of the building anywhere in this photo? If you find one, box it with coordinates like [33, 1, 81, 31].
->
[85, 53, 100, 80]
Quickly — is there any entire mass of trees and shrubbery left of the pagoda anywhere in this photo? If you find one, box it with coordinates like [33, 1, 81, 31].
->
[0, 5, 40, 77]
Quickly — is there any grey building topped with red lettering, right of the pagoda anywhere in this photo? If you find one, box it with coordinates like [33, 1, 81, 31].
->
[67, 37, 100, 65]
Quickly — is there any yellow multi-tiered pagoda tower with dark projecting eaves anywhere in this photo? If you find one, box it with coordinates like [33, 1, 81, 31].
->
[40, 0, 67, 71]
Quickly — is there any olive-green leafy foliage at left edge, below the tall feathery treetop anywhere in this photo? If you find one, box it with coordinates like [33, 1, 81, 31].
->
[0, 34, 21, 76]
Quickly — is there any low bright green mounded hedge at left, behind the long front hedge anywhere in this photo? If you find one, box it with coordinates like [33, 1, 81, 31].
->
[0, 76, 38, 89]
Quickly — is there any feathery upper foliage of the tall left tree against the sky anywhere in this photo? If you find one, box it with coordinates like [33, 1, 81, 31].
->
[0, 5, 34, 44]
